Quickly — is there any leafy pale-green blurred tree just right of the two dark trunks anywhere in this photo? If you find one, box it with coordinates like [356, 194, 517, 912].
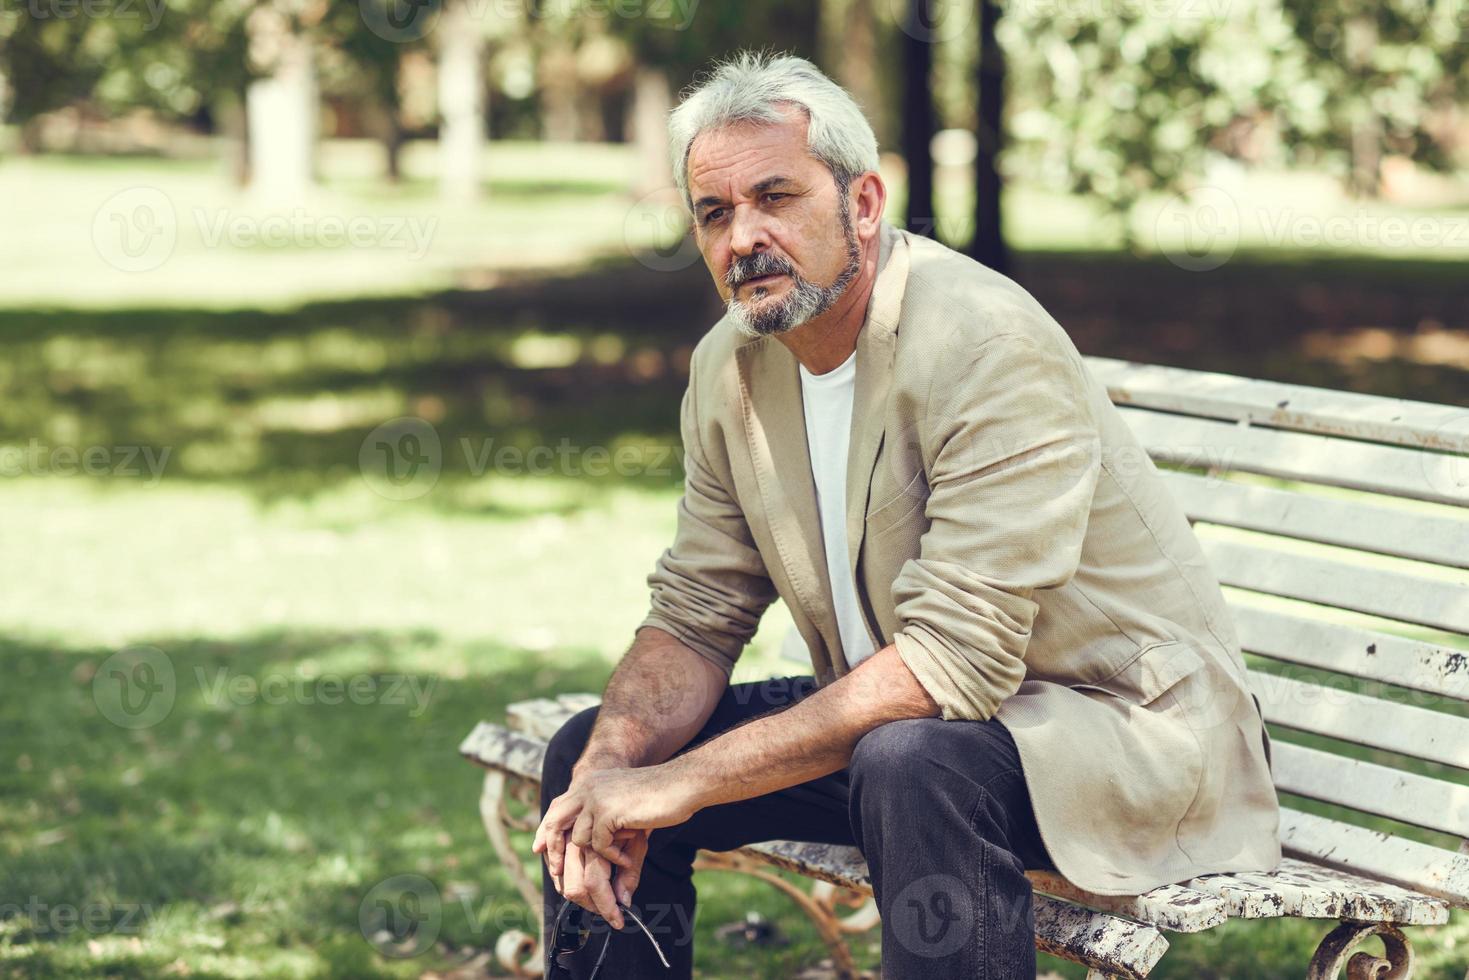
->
[997, 0, 1313, 238]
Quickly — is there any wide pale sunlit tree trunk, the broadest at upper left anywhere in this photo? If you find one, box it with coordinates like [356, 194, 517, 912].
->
[245, 19, 317, 201]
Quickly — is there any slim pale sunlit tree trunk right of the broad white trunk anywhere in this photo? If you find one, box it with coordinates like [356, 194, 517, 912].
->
[436, 0, 485, 201]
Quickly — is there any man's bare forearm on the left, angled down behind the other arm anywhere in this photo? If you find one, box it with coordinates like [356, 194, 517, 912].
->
[574, 626, 729, 771]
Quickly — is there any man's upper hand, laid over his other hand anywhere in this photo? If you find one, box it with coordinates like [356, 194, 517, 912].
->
[530, 765, 698, 880]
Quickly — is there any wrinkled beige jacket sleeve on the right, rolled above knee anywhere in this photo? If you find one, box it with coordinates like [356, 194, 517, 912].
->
[893, 334, 1100, 720]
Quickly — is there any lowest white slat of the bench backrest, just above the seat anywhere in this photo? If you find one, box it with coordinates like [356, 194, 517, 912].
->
[1281, 807, 1469, 908]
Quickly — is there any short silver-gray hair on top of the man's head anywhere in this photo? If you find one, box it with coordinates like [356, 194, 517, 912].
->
[668, 51, 877, 210]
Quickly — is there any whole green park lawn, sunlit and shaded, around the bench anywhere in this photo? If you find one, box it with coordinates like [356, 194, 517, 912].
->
[0, 144, 1469, 980]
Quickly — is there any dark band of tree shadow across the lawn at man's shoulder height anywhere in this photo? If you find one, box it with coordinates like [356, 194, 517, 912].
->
[0, 253, 1469, 508]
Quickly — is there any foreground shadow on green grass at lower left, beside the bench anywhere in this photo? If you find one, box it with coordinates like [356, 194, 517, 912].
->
[0, 632, 607, 976]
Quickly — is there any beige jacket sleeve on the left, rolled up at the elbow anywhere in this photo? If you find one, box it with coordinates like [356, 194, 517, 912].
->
[638, 357, 776, 674]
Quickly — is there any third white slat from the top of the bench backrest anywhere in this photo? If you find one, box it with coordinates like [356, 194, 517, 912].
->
[1162, 464, 1469, 569]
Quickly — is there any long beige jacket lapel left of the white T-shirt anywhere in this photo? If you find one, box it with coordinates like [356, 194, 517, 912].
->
[735, 338, 842, 660]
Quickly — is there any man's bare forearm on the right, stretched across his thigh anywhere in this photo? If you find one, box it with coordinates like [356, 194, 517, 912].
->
[661, 646, 939, 808]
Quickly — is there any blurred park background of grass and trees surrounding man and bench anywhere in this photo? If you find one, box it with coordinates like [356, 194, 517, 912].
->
[0, 0, 1469, 977]
